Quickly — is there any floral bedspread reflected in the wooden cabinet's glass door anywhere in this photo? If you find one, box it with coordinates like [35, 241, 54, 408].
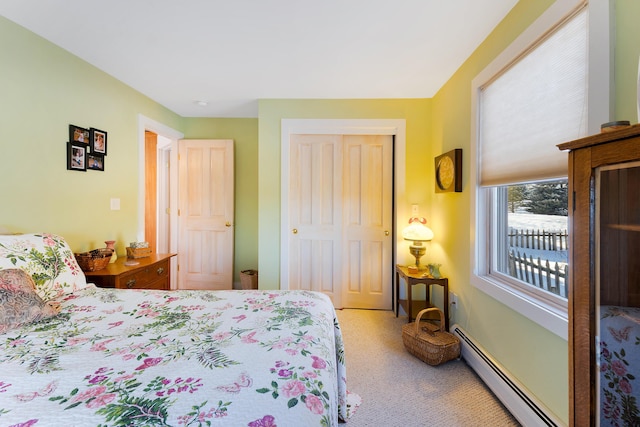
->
[599, 306, 640, 426]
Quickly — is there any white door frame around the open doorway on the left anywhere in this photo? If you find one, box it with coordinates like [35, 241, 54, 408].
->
[136, 114, 184, 289]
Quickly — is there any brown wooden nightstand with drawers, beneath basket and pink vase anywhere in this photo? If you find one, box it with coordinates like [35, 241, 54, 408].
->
[84, 254, 175, 290]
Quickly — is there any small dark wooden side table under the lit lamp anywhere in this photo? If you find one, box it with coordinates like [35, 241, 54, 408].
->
[395, 265, 449, 331]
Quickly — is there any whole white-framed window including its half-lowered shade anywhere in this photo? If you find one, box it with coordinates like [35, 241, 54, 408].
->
[471, 0, 609, 338]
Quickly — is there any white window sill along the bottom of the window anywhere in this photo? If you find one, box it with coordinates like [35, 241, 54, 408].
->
[471, 274, 568, 340]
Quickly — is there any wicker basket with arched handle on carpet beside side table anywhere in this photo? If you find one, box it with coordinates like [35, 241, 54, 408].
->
[402, 307, 460, 366]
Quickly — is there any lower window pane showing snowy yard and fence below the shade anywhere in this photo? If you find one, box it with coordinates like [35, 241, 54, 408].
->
[488, 179, 568, 308]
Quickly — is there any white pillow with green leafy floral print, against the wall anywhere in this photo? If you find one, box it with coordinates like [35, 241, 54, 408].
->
[0, 233, 87, 301]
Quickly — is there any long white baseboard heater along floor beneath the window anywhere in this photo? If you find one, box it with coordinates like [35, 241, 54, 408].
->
[450, 324, 565, 427]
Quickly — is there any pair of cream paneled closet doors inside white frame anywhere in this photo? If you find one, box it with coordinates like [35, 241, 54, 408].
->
[288, 135, 393, 309]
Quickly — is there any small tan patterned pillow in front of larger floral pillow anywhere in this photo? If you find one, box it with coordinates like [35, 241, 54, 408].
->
[0, 268, 60, 333]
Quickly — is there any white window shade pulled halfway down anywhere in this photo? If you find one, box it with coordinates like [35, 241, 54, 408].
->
[480, 9, 588, 186]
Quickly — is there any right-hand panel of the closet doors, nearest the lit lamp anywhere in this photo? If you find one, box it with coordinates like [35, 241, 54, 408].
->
[342, 135, 393, 309]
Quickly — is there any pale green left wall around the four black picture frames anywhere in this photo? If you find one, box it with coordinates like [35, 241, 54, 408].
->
[0, 17, 183, 255]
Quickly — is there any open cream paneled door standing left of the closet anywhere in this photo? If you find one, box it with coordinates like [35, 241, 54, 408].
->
[178, 140, 234, 289]
